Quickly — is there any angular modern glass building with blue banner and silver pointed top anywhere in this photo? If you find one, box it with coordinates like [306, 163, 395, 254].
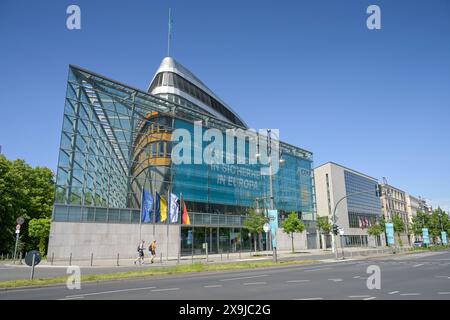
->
[49, 58, 315, 257]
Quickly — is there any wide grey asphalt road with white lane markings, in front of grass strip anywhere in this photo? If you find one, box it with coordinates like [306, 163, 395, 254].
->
[0, 252, 450, 300]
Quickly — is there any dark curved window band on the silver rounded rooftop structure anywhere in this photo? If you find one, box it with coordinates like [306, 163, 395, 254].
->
[149, 72, 244, 126]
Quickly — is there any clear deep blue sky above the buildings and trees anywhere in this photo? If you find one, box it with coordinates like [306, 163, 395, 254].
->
[0, 0, 450, 209]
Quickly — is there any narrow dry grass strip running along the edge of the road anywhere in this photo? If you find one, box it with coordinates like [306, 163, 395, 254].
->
[0, 260, 317, 289]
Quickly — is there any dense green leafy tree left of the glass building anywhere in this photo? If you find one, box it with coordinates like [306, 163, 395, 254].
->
[0, 155, 55, 252]
